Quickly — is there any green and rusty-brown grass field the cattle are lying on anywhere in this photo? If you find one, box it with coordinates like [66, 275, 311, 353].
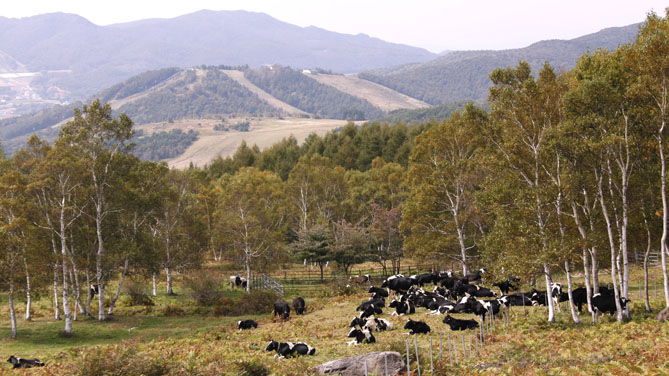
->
[0, 264, 669, 375]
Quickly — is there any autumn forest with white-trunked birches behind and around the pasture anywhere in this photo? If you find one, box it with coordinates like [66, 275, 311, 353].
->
[0, 14, 669, 337]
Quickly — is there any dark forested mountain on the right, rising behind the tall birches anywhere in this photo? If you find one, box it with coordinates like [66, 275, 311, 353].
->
[359, 24, 639, 105]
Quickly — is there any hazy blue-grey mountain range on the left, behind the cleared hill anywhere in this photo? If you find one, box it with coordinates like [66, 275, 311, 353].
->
[0, 10, 436, 100]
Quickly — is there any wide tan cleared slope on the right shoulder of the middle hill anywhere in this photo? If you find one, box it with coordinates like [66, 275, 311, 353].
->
[305, 73, 429, 111]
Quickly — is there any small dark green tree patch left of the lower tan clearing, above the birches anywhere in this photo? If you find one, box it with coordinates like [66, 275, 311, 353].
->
[132, 129, 198, 161]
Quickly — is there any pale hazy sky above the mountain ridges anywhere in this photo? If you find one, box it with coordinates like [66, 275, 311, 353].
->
[0, 0, 669, 52]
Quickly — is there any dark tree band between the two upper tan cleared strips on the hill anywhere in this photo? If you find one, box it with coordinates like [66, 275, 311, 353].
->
[244, 65, 383, 120]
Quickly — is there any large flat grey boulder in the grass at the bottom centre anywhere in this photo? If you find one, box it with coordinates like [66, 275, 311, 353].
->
[315, 351, 404, 376]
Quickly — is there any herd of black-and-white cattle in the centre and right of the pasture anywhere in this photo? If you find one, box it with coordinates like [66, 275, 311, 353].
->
[236, 269, 629, 358]
